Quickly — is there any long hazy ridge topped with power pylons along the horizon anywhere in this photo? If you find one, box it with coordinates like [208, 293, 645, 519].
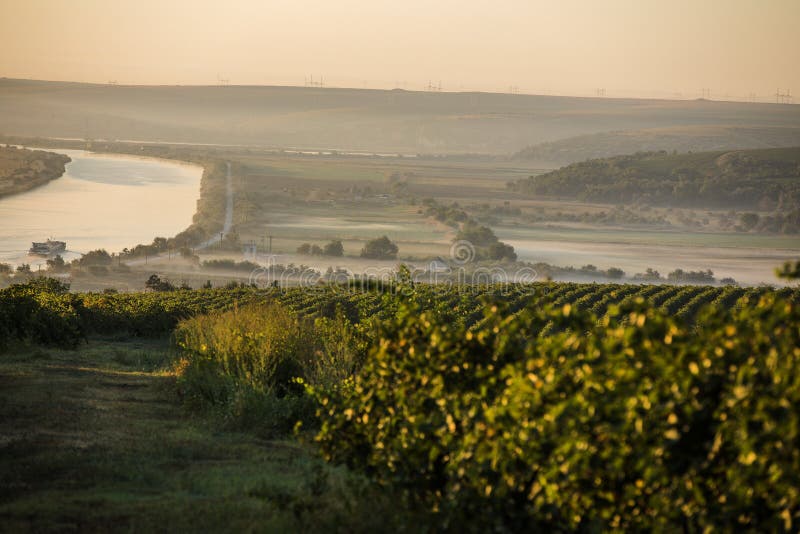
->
[0, 79, 800, 155]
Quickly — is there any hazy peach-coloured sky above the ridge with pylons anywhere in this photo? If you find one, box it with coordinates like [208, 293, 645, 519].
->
[0, 0, 800, 101]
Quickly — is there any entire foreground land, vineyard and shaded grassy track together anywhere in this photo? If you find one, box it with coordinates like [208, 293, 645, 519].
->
[0, 280, 800, 531]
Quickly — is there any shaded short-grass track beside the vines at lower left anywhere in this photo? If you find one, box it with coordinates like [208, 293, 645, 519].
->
[0, 339, 400, 532]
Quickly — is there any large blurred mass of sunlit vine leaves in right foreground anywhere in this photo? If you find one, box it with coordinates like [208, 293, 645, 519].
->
[315, 296, 800, 531]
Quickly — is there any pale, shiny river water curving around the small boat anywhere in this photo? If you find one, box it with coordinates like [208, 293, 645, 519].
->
[0, 149, 202, 270]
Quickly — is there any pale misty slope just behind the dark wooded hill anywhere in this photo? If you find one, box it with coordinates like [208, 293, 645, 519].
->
[515, 125, 800, 167]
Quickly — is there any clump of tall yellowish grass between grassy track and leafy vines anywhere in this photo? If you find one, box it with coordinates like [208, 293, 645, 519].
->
[175, 303, 367, 434]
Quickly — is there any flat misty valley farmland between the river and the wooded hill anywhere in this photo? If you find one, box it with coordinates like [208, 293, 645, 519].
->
[1, 137, 800, 290]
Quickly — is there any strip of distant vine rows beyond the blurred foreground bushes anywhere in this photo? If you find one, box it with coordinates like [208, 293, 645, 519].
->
[0, 282, 800, 346]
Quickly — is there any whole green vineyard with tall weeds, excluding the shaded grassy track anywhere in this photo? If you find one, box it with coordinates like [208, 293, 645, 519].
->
[0, 279, 800, 532]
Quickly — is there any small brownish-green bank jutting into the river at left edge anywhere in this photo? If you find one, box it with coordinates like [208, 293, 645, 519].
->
[0, 146, 70, 198]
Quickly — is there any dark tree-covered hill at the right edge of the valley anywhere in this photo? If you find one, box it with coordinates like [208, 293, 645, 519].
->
[509, 147, 800, 222]
